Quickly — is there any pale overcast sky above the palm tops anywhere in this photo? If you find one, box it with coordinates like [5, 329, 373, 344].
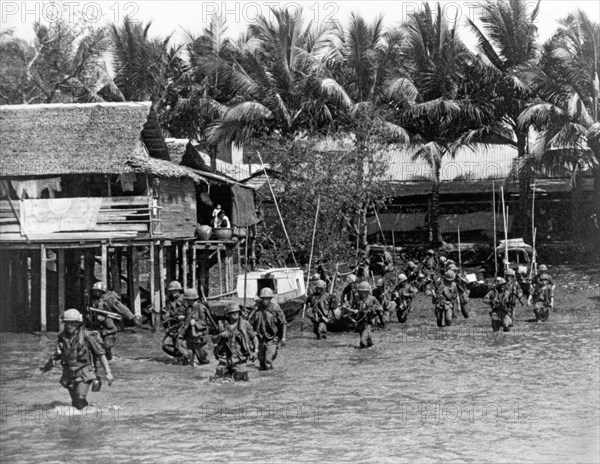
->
[0, 0, 600, 46]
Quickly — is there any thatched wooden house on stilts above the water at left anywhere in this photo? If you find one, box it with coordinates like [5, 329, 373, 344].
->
[0, 102, 247, 332]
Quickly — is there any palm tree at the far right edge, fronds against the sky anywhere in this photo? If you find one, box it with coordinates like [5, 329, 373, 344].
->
[519, 11, 600, 243]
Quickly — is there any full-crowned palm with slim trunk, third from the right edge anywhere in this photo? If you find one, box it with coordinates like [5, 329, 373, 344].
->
[388, 3, 490, 245]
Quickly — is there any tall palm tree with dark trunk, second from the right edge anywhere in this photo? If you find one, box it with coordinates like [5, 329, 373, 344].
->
[467, 0, 539, 236]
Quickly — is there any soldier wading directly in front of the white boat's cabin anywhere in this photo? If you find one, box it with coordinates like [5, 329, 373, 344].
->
[249, 287, 287, 371]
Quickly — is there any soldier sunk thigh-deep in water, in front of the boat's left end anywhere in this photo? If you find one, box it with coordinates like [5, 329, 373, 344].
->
[212, 303, 258, 381]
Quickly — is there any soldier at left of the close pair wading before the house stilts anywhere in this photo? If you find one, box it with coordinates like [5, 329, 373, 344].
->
[162, 280, 187, 362]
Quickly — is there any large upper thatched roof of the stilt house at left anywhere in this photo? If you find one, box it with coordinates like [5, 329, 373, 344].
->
[0, 102, 169, 176]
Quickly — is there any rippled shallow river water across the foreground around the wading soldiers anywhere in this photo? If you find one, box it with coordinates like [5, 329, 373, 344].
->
[0, 278, 600, 463]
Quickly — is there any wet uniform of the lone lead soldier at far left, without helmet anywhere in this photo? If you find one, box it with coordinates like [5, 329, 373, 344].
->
[55, 327, 106, 409]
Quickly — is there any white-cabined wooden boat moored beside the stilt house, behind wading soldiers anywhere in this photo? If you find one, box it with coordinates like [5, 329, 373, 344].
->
[208, 268, 306, 322]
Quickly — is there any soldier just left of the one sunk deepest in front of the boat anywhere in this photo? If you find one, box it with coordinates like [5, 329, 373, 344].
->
[177, 288, 212, 366]
